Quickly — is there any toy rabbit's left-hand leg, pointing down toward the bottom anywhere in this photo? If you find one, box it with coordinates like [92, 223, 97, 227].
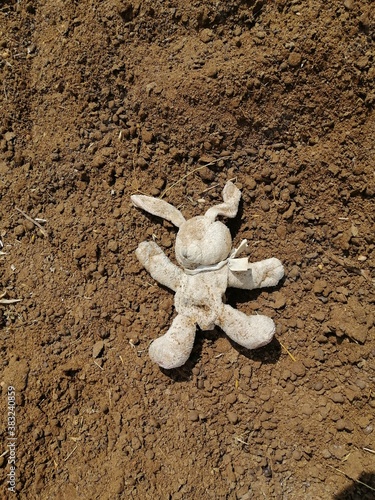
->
[149, 314, 196, 370]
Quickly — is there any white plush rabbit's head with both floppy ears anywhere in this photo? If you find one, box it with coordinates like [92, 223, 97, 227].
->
[131, 182, 241, 270]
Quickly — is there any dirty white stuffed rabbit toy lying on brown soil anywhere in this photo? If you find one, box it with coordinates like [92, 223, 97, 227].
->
[131, 182, 284, 369]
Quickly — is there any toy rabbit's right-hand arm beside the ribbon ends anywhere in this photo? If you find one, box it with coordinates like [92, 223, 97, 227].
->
[228, 258, 284, 290]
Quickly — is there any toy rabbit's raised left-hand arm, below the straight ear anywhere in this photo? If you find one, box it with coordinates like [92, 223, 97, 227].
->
[135, 241, 183, 292]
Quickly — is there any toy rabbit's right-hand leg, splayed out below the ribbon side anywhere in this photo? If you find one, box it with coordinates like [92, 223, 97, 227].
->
[217, 304, 275, 349]
